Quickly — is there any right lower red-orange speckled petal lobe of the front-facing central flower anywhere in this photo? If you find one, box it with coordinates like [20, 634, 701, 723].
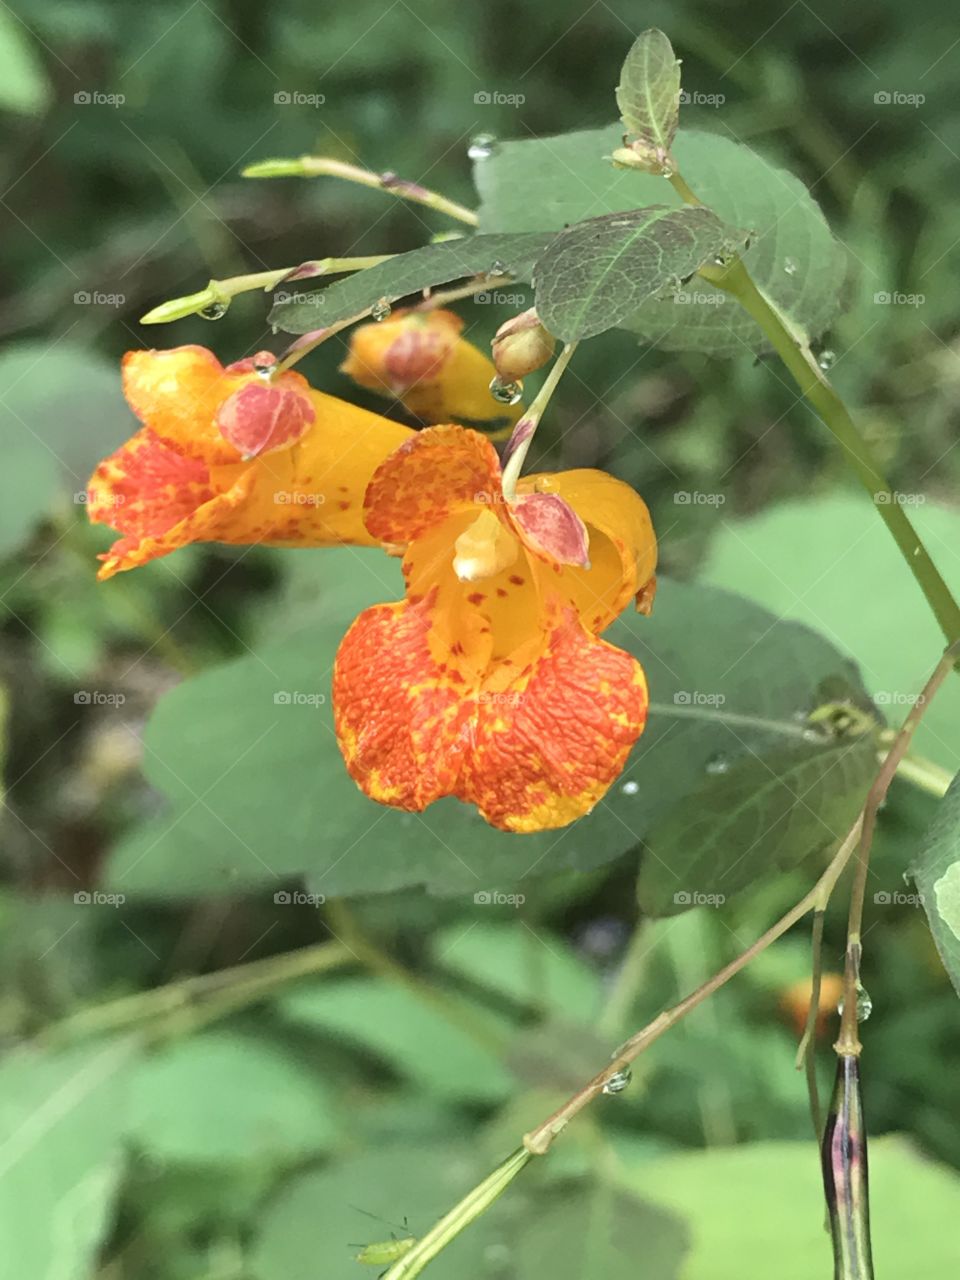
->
[457, 609, 648, 832]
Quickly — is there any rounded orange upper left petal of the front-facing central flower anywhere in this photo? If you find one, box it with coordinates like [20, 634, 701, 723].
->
[365, 426, 502, 543]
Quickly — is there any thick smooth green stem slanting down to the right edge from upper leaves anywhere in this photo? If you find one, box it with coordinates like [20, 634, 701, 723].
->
[669, 173, 960, 644]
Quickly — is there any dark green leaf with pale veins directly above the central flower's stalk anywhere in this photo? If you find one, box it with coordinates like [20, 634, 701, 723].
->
[535, 205, 746, 342]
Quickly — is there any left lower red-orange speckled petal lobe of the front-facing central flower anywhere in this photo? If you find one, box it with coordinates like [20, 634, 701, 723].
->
[333, 600, 476, 810]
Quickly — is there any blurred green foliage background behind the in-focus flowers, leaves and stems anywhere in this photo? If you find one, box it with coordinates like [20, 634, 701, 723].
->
[0, 0, 960, 1280]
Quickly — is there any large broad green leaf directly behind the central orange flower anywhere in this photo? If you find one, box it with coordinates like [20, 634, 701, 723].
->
[108, 549, 880, 920]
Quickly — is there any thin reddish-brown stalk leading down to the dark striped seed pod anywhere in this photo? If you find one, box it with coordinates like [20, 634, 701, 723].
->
[833, 640, 960, 1056]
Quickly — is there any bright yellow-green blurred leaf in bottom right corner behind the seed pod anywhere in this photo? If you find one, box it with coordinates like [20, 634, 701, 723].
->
[616, 1137, 960, 1280]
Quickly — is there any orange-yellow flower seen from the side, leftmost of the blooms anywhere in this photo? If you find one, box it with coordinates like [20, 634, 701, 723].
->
[87, 347, 412, 579]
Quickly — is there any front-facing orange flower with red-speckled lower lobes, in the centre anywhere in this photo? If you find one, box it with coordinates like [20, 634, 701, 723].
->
[334, 426, 657, 831]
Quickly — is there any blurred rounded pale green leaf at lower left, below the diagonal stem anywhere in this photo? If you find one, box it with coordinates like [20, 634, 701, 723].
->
[131, 1030, 338, 1164]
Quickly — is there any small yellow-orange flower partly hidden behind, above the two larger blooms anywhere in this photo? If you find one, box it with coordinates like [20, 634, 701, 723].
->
[340, 311, 522, 434]
